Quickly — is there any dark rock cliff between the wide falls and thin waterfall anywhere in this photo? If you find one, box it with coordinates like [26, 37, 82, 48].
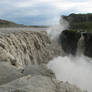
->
[60, 30, 81, 55]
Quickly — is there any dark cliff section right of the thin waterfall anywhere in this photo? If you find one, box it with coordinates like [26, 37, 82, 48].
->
[83, 33, 92, 57]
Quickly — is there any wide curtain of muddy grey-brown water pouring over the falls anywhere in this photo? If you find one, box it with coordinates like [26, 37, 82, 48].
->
[0, 31, 55, 68]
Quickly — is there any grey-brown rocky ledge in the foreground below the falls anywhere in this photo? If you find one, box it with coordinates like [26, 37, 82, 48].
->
[0, 62, 84, 92]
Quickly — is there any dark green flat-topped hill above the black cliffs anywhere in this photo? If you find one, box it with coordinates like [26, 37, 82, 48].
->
[63, 13, 92, 30]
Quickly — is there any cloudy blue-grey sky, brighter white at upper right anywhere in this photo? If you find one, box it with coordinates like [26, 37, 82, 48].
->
[0, 0, 92, 25]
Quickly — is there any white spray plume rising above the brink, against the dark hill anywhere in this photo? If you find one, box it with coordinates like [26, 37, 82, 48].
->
[46, 17, 69, 41]
